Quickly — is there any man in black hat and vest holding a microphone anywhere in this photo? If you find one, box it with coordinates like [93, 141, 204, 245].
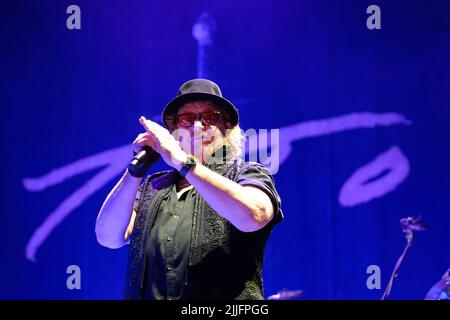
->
[95, 79, 283, 300]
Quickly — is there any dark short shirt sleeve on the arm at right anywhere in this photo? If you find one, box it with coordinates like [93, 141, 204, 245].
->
[236, 162, 284, 224]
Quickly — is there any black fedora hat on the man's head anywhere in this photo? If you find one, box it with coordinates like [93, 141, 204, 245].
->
[162, 79, 239, 128]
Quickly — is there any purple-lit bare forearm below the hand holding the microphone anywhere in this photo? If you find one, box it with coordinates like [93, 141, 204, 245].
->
[95, 171, 141, 249]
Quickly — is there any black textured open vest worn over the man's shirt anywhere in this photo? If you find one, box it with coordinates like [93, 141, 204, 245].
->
[124, 160, 275, 300]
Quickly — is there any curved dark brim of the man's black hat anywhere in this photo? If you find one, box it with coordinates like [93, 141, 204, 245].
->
[162, 92, 239, 127]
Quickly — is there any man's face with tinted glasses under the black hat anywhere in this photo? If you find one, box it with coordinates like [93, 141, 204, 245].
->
[174, 101, 231, 160]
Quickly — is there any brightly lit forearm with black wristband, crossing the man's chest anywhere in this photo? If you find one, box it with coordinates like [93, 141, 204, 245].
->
[186, 163, 273, 232]
